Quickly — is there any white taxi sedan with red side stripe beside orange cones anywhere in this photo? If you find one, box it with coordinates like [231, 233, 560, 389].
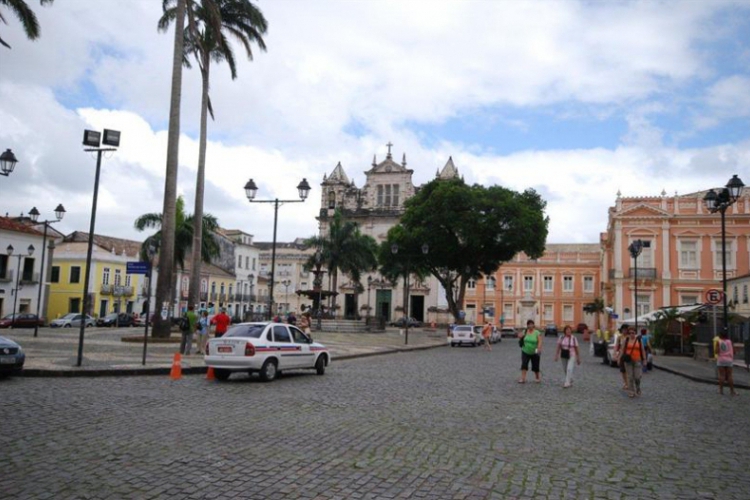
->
[203, 323, 331, 382]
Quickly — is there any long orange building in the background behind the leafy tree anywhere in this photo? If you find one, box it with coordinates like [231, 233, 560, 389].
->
[464, 243, 601, 329]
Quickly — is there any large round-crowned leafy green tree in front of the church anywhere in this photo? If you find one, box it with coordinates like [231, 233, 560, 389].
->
[380, 179, 549, 320]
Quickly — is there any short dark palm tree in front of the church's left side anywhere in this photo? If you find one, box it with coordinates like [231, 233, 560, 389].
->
[305, 209, 378, 310]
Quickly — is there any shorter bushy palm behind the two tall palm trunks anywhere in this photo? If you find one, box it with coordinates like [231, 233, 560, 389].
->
[134, 196, 221, 337]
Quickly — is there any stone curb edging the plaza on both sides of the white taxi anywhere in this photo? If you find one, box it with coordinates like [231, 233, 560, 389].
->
[16, 344, 445, 378]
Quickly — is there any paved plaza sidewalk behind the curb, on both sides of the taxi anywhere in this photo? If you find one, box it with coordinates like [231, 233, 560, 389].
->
[0, 328, 446, 377]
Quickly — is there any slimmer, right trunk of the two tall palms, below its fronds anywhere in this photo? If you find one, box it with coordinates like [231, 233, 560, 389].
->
[188, 54, 211, 305]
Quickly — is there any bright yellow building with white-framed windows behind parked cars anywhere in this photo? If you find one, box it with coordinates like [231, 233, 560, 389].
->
[48, 231, 147, 319]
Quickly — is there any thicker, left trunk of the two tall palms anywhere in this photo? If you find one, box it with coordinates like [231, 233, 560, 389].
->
[153, 0, 187, 337]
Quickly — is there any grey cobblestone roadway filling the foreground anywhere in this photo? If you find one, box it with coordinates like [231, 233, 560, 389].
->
[0, 340, 750, 499]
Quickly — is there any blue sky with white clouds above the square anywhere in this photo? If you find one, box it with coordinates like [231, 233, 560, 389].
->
[0, 0, 750, 247]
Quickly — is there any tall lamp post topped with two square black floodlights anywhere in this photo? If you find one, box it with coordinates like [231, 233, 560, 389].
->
[76, 129, 120, 366]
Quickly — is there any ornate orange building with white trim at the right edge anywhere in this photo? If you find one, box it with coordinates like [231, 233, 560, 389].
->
[601, 189, 750, 320]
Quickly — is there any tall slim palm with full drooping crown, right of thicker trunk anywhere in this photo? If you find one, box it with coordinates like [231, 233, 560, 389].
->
[159, 0, 268, 314]
